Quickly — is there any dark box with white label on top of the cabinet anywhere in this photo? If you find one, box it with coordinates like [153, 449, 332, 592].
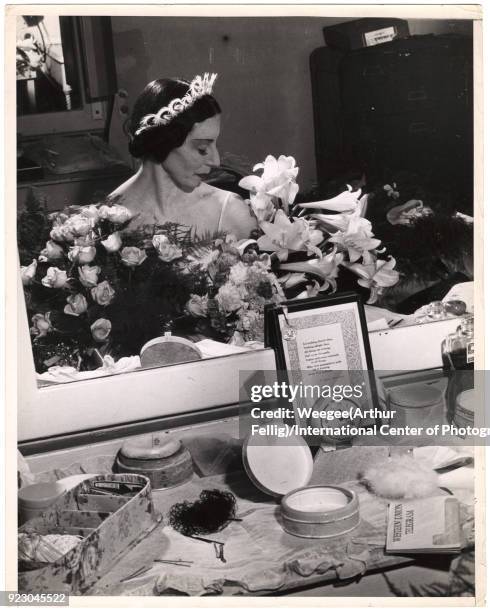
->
[323, 18, 410, 51]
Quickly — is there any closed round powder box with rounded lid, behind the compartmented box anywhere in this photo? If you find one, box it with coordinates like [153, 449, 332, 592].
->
[116, 434, 194, 489]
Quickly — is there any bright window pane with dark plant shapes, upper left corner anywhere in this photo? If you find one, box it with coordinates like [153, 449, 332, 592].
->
[16, 15, 82, 116]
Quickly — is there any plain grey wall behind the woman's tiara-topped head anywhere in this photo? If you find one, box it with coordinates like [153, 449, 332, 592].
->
[111, 17, 472, 189]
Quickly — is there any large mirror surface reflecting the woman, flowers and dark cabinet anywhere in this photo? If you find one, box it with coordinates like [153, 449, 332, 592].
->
[17, 17, 473, 382]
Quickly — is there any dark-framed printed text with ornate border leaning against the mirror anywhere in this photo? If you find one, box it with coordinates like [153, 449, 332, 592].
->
[264, 292, 379, 426]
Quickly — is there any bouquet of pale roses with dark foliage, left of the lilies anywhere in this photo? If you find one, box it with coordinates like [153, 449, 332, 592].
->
[19, 194, 214, 372]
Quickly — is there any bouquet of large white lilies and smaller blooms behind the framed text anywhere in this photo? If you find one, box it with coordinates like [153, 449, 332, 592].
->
[182, 155, 399, 344]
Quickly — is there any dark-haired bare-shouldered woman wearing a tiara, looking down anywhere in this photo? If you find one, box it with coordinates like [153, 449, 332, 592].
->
[111, 73, 256, 239]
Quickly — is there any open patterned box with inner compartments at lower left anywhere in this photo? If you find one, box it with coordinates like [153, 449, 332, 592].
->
[18, 474, 161, 595]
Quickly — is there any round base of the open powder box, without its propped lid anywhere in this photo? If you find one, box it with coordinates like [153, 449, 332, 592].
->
[281, 485, 361, 538]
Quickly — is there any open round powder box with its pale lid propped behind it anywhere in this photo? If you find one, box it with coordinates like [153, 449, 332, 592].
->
[243, 435, 360, 538]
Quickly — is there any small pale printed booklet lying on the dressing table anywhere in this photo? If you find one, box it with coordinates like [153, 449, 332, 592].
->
[386, 495, 464, 553]
